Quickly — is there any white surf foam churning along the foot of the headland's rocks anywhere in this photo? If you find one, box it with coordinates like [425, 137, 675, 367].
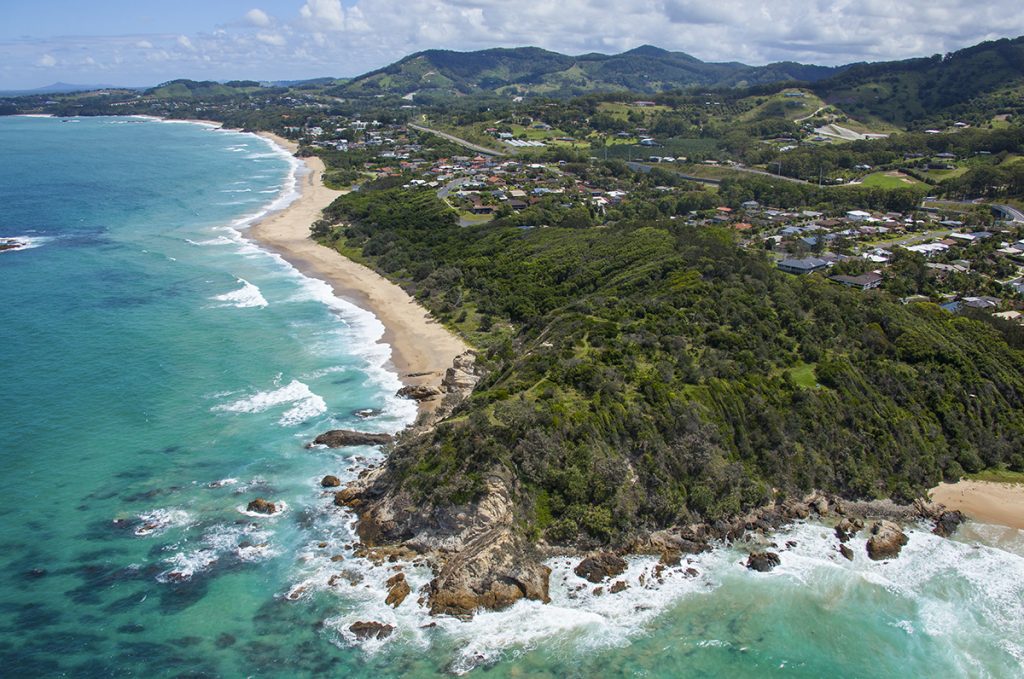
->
[307, 520, 1024, 675]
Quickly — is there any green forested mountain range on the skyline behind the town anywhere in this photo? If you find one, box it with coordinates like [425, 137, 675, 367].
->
[330, 38, 1024, 126]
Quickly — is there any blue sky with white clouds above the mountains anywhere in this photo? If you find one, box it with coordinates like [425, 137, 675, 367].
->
[0, 0, 1024, 89]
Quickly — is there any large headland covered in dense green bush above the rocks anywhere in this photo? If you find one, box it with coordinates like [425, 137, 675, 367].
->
[317, 189, 1024, 543]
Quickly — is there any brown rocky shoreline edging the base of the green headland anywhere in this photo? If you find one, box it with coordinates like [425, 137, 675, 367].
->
[314, 352, 965, 622]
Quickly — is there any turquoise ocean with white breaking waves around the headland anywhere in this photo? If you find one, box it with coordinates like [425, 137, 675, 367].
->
[0, 118, 1024, 677]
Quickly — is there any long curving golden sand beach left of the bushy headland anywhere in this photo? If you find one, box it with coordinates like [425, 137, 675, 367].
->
[249, 132, 469, 413]
